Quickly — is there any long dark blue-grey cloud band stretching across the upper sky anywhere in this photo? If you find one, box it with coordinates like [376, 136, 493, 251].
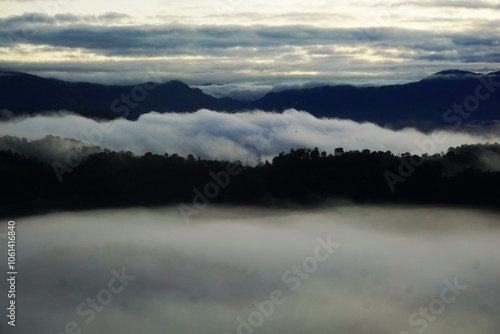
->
[0, 14, 498, 56]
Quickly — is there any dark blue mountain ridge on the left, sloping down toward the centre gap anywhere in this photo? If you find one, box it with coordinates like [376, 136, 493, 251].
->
[0, 71, 241, 119]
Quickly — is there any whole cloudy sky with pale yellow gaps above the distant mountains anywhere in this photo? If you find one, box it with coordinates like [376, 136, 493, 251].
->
[0, 0, 500, 94]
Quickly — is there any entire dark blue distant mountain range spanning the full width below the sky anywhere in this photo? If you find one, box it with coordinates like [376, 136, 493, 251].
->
[0, 70, 500, 126]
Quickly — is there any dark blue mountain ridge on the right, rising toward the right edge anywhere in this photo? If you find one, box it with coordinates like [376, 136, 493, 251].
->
[251, 70, 500, 125]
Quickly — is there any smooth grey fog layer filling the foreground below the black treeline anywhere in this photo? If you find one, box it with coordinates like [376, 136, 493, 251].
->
[0, 205, 500, 334]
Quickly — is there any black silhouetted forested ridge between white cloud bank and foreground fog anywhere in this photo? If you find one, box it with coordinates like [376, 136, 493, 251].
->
[0, 144, 500, 218]
